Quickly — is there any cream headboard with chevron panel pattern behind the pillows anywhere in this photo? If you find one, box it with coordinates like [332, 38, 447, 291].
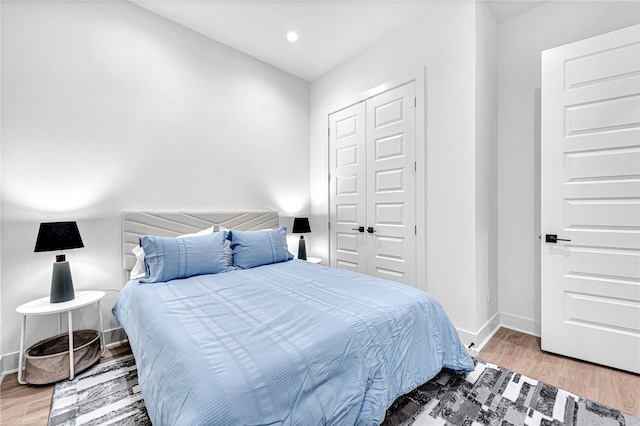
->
[122, 211, 279, 271]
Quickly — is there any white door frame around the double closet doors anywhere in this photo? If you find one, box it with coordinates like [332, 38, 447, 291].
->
[324, 66, 429, 291]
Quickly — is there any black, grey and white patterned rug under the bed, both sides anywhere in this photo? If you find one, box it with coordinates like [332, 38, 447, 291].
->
[49, 355, 640, 426]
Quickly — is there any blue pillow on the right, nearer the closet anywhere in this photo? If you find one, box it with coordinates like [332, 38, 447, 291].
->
[229, 226, 293, 269]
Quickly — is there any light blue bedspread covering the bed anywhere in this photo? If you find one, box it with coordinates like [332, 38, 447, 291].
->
[113, 260, 473, 426]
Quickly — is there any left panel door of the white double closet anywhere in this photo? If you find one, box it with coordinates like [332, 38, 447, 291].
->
[329, 102, 367, 274]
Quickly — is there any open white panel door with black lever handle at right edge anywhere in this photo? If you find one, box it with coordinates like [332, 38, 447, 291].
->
[541, 26, 640, 373]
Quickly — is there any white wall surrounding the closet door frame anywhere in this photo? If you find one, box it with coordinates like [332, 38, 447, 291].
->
[311, 2, 495, 343]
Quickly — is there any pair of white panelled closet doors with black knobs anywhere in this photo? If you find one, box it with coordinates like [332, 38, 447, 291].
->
[329, 82, 417, 287]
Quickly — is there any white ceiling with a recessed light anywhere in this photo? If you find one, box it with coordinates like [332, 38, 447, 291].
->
[130, 0, 544, 81]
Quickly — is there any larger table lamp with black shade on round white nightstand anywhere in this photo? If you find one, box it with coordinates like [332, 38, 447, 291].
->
[34, 222, 84, 303]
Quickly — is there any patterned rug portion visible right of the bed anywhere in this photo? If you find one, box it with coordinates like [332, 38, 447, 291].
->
[383, 360, 640, 426]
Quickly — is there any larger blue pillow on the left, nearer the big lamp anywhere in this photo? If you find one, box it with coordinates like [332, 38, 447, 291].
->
[140, 232, 227, 283]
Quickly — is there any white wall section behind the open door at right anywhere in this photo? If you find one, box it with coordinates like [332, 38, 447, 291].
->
[498, 1, 640, 335]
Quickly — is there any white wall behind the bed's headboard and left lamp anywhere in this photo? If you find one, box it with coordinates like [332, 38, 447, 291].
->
[0, 1, 309, 365]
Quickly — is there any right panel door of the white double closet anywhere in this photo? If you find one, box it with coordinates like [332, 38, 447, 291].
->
[366, 83, 416, 286]
